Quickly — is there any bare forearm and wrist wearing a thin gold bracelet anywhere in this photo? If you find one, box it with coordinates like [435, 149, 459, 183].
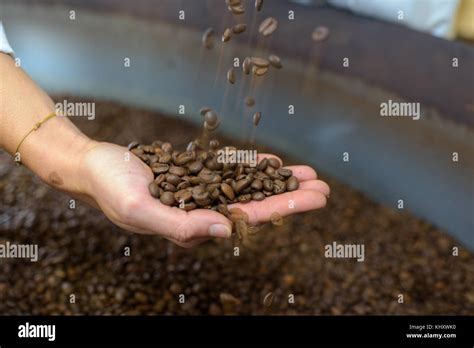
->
[0, 53, 95, 194]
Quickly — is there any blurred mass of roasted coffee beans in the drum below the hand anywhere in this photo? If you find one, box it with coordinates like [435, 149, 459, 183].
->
[0, 95, 474, 315]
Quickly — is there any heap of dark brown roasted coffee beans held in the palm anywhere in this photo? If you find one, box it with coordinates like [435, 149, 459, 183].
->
[129, 140, 299, 215]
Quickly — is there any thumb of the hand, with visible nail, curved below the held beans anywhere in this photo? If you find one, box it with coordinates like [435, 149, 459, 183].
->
[123, 196, 232, 243]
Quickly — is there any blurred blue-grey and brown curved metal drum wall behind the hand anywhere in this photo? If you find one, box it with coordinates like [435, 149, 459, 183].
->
[0, 0, 474, 249]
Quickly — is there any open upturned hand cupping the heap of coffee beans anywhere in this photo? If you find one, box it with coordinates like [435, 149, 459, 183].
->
[80, 143, 329, 247]
